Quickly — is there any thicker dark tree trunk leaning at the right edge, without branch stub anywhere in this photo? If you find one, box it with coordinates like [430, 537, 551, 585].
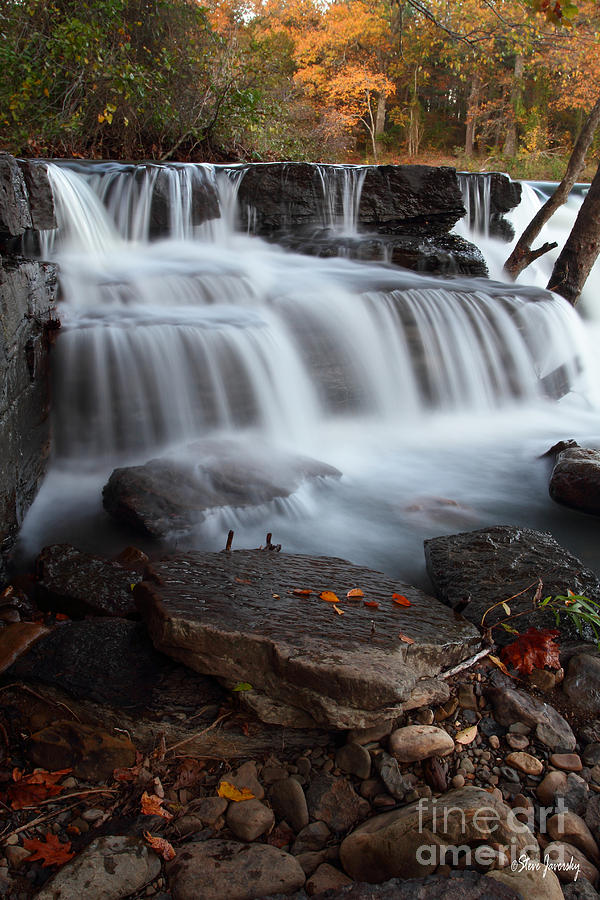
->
[548, 158, 600, 306]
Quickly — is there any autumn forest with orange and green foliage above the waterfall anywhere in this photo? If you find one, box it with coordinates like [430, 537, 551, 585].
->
[0, 0, 600, 180]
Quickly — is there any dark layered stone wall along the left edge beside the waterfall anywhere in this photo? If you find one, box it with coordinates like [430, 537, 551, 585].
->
[0, 153, 58, 585]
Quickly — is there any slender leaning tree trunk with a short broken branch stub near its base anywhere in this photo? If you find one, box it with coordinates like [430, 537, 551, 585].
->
[504, 97, 600, 278]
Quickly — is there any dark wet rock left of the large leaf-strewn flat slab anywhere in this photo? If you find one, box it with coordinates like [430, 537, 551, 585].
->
[35, 544, 141, 618]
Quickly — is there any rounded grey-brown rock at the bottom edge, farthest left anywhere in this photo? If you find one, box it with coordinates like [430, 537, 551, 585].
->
[36, 835, 160, 900]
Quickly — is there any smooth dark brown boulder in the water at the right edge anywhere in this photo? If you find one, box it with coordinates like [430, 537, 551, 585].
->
[549, 447, 600, 516]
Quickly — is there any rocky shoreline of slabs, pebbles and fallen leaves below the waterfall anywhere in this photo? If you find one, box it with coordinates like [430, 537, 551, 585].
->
[0, 528, 600, 900]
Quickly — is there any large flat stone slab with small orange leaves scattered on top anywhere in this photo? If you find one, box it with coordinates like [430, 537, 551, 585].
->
[134, 550, 480, 729]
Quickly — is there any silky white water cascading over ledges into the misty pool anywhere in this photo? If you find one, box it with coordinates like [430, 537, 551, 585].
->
[16, 166, 600, 583]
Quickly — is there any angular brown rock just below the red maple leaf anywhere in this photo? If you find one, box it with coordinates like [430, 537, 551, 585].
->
[486, 678, 577, 751]
